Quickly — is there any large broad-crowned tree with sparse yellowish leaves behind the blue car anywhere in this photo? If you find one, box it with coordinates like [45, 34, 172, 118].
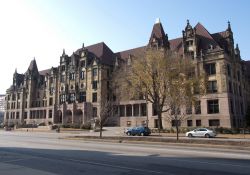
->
[116, 49, 206, 130]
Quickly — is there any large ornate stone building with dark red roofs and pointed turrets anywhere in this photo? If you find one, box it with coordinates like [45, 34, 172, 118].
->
[4, 20, 250, 128]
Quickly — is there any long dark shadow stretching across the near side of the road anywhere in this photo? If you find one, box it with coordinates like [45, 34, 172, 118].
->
[0, 147, 250, 175]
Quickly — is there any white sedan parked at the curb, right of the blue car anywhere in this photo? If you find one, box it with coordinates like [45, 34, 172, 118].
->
[186, 128, 216, 138]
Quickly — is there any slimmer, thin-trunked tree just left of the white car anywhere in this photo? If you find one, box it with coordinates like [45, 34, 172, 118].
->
[165, 57, 207, 140]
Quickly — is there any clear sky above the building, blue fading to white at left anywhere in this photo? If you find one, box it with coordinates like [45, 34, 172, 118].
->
[0, 0, 250, 93]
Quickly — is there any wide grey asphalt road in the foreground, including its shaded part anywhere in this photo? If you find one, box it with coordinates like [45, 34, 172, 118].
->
[0, 131, 250, 175]
